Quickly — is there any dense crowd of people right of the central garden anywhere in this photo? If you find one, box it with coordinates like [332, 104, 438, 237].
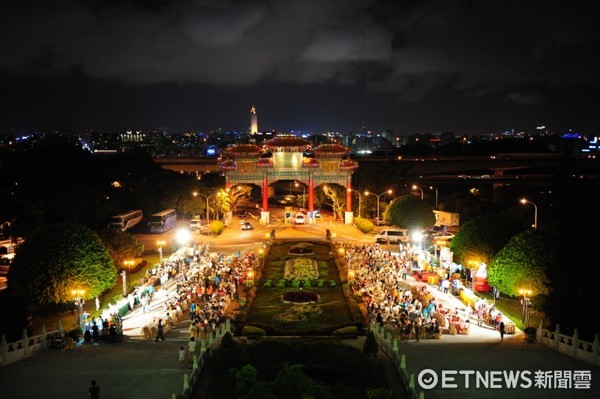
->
[343, 243, 470, 341]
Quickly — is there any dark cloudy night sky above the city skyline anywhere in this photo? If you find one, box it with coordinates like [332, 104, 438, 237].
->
[0, 0, 600, 134]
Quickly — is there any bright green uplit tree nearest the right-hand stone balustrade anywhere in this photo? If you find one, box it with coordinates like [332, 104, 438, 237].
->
[487, 230, 556, 296]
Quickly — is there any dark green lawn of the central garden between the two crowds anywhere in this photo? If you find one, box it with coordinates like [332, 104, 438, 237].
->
[246, 244, 352, 334]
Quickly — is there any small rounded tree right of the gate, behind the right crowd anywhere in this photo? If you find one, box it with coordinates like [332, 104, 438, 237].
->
[383, 195, 435, 229]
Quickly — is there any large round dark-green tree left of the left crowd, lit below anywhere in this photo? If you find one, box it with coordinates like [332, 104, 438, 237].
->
[8, 224, 117, 306]
